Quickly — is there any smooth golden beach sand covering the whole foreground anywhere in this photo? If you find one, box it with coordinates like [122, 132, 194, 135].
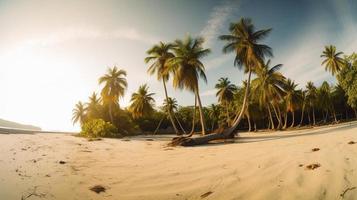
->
[0, 123, 357, 200]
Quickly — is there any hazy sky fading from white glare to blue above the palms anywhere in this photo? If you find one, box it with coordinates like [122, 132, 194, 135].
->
[0, 0, 357, 130]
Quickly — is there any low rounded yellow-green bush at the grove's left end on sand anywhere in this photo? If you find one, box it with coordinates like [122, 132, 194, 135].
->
[80, 119, 121, 138]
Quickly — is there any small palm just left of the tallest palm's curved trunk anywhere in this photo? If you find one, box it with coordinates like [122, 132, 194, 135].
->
[215, 78, 237, 125]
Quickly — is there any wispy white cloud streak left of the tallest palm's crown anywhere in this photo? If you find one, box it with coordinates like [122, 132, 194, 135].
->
[200, 1, 238, 47]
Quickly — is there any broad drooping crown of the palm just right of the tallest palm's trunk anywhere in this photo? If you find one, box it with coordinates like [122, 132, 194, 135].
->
[252, 60, 285, 106]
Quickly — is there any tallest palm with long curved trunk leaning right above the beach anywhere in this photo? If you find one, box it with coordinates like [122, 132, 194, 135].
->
[219, 18, 272, 135]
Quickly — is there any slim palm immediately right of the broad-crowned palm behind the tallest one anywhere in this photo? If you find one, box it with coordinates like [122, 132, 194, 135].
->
[284, 79, 300, 128]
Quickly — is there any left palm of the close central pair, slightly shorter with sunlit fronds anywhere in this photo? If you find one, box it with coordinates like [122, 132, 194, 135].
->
[145, 42, 178, 134]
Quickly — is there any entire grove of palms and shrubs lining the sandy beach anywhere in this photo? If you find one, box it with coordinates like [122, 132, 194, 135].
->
[73, 18, 357, 145]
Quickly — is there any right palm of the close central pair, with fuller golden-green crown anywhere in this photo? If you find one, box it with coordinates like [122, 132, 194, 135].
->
[169, 36, 210, 135]
